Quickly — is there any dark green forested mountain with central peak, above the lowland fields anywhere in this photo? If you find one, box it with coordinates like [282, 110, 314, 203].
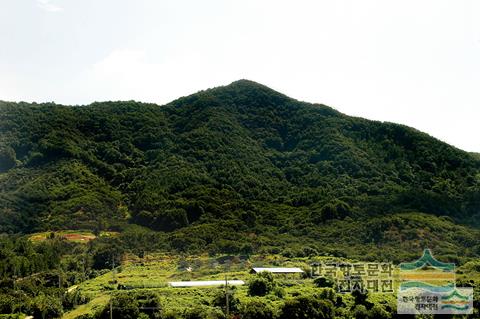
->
[0, 80, 480, 259]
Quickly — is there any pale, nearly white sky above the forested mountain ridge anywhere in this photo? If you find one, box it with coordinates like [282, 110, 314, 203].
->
[0, 0, 480, 152]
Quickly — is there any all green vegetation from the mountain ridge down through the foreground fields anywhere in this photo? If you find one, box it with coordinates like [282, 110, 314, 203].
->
[0, 80, 480, 319]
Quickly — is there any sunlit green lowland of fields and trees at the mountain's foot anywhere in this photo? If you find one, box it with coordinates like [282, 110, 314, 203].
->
[0, 230, 480, 319]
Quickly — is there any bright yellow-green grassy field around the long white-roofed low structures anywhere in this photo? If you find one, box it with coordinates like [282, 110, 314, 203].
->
[64, 255, 402, 319]
